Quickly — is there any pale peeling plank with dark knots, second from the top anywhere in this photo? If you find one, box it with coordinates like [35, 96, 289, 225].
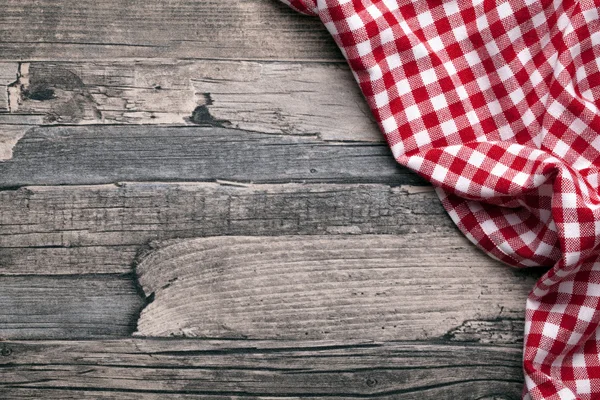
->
[13, 60, 384, 142]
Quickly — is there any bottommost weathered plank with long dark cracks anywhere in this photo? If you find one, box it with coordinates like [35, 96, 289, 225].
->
[0, 339, 523, 400]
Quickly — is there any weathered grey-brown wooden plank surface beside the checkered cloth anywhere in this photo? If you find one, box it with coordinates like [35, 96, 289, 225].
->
[0, 0, 541, 400]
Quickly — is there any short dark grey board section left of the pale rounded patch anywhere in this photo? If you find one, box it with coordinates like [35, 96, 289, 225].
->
[0, 271, 143, 338]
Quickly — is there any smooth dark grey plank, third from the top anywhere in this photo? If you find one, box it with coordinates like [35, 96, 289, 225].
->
[0, 126, 424, 188]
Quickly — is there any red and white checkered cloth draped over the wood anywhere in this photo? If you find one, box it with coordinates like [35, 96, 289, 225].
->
[282, 0, 600, 400]
